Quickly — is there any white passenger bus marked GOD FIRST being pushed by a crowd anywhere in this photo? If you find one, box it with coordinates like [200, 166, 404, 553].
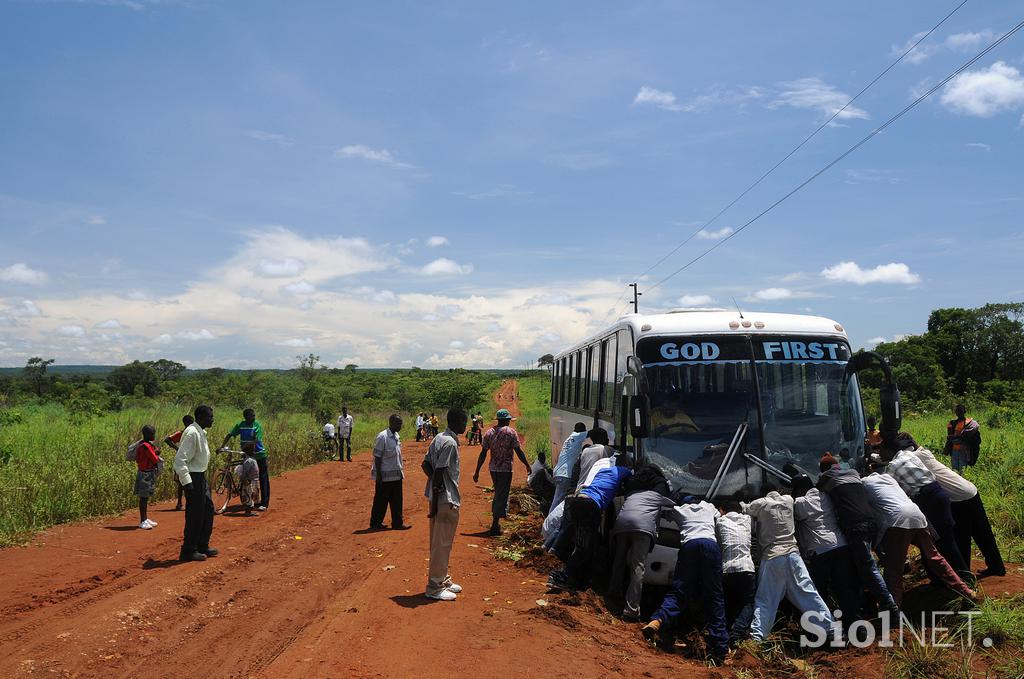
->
[550, 309, 899, 584]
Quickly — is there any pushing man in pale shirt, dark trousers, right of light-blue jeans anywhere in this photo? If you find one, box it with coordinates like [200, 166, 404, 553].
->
[793, 474, 860, 628]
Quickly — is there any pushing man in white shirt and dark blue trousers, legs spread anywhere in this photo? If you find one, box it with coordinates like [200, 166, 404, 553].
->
[642, 496, 729, 664]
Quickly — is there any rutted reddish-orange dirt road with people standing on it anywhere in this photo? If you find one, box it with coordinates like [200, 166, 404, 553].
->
[0, 382, 688, 678]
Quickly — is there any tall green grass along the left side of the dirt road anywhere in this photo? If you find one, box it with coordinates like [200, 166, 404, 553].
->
[0, 404, 386, 545]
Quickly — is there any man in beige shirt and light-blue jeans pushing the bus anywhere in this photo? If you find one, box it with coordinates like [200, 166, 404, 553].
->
[742, 491, 835, 641]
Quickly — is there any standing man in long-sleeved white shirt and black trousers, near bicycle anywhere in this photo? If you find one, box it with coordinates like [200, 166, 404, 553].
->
[174, 406, 217, 561]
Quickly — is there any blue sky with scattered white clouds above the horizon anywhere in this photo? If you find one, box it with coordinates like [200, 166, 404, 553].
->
[0, 0, 1024, 368]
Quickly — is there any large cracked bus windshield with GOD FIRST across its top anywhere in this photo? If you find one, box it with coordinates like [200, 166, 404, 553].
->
[637, 335, 864, 498]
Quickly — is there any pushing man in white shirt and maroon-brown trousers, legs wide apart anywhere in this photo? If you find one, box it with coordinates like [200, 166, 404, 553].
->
[864, 472, 976, 605]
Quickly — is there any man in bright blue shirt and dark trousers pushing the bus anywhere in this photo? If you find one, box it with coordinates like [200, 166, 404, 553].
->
[548, 457, 633, 591]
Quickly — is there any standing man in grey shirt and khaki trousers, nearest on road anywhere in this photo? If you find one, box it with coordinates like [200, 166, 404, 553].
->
[423, 409, 468, 601]
